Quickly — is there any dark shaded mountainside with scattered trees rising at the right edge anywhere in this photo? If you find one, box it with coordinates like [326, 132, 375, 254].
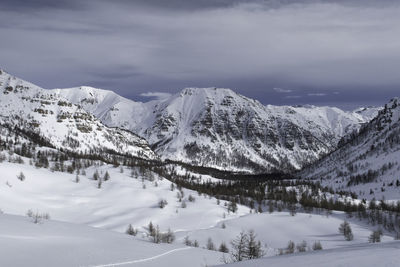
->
[301, 98, 400, 201]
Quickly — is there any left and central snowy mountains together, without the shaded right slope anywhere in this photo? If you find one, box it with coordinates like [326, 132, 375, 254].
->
[0, 71, 381, 173]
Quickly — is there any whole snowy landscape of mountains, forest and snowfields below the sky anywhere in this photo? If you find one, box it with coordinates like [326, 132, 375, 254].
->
[0, 71, 400, 267]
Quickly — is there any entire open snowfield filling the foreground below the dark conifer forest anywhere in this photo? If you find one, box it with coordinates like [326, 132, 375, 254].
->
[0, 159, 400, 267]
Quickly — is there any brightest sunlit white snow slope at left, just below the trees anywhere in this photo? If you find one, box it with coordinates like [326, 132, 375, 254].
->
[0, 160, 249, 232]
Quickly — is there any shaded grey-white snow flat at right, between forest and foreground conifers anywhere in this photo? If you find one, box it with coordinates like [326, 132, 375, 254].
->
[177, 212, 393, 256]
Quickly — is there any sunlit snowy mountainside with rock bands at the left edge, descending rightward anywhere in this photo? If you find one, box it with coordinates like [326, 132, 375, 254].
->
[0, 71, 157, 159]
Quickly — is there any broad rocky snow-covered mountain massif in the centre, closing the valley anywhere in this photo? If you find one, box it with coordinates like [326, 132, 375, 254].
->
[53, 87, 377, 172]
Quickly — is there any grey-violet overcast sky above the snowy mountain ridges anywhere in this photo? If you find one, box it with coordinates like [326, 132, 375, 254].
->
[0, 0, 400, 109]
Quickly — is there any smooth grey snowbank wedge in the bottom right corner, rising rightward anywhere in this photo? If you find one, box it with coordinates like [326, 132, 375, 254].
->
[219, 241, 400, 267]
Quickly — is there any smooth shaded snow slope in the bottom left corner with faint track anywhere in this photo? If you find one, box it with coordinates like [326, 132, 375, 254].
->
[0, 214, 222, 267]
